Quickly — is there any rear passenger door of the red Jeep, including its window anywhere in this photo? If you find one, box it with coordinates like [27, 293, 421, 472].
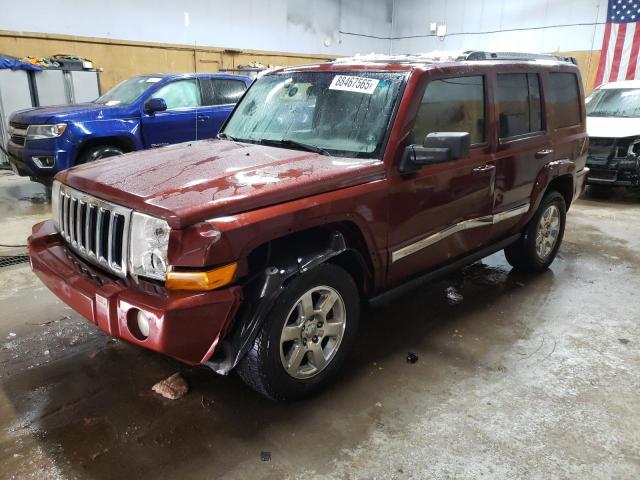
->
[492, 71, 553, 237]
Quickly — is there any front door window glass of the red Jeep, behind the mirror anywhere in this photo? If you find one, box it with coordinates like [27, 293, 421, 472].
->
[412, 75, 484, 145]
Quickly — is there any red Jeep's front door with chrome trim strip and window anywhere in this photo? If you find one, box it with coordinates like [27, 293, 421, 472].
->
[389, 75, 495, 286]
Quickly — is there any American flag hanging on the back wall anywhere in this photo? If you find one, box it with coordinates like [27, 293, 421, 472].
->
[595, 0, 640, 86]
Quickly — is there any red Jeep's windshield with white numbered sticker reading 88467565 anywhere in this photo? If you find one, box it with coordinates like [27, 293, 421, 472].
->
[221, 71, 405, 158]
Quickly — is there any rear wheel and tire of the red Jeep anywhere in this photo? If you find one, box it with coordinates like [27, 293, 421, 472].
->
[504, 192, 567, 272]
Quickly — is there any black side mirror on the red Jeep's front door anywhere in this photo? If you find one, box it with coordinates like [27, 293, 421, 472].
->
[400, 132, 471, 173]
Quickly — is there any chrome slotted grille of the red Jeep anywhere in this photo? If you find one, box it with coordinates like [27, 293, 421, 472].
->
[56, 185, 131, 277]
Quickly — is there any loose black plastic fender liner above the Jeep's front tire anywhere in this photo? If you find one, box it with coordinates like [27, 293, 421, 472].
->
[204, 232, 349, 375]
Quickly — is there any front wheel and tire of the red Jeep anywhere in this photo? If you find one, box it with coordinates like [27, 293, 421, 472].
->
[236, 263, 360, 400]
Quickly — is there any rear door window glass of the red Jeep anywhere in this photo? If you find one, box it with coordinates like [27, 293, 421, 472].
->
[496, 73, 542, 138]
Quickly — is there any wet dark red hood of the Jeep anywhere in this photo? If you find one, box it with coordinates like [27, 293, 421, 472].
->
[57, 140, 384, 228]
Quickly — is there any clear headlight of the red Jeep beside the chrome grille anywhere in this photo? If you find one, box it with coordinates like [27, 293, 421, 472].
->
[129, 212, 170, 280]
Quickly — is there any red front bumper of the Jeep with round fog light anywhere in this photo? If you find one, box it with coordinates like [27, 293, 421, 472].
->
[29, 220, 242, 365]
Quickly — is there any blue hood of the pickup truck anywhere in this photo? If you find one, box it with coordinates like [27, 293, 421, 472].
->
[10, 103, 128, 124]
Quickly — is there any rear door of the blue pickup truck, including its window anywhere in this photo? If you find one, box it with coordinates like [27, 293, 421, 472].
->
[198, 77, 247, 140]
